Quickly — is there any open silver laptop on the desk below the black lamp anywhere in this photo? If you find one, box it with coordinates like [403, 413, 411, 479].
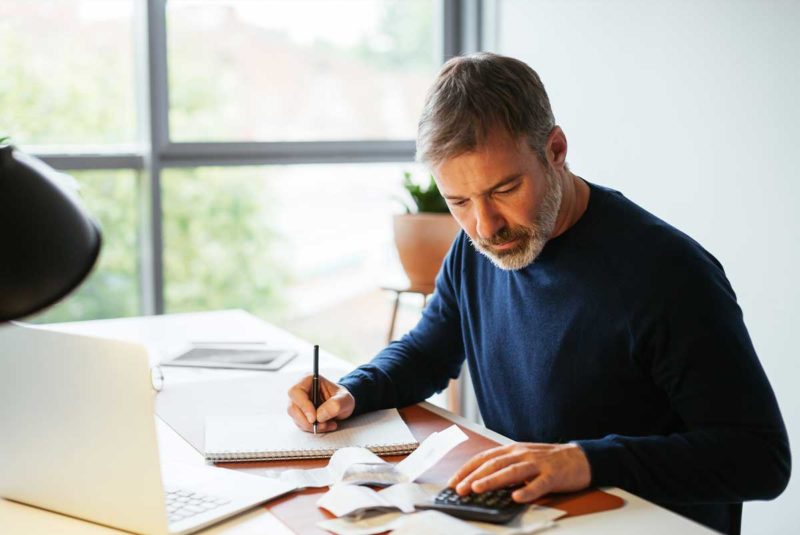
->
[0, 323, 293, 534]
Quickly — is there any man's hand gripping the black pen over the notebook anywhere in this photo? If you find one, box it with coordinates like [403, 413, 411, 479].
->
[287, 375, 356, 433]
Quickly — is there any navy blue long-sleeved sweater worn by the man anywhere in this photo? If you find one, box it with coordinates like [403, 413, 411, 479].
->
[341, 184, 790, 533]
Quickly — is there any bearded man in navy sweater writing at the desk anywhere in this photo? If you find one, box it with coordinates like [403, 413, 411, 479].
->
[289, 54, 790, 533]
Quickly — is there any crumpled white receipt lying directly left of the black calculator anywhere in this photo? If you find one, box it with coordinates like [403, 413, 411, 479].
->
[317, 483, 440, 516]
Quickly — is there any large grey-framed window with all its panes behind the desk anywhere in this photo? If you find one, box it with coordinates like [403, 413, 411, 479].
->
[0, 0, 480, 360]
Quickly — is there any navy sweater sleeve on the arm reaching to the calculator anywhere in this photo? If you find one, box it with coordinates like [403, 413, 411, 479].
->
[575, 249, 791, 504]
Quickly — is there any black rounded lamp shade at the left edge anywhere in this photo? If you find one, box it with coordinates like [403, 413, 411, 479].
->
[0, 145, 101, 321]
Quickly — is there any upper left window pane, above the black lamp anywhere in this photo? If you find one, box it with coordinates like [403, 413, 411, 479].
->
[0, 0, 136, 145]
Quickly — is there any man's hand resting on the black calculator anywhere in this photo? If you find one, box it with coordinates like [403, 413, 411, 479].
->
[448, 443, 592, 503]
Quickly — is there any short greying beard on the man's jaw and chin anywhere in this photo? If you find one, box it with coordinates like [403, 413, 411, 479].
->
[470, 170, 563, 271]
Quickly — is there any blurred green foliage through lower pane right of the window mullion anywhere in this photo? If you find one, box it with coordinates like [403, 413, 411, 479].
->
[162, 167, 288, 317]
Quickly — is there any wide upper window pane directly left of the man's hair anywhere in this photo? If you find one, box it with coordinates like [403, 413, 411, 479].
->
[167, 0, 439, 141]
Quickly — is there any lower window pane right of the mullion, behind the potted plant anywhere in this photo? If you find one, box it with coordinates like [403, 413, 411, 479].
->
[163, 164, 424, 360]
